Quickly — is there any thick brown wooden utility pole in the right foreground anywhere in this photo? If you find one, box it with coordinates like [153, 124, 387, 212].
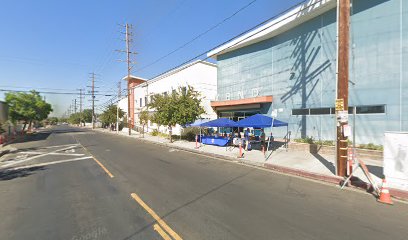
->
[336, 0, 350, 177]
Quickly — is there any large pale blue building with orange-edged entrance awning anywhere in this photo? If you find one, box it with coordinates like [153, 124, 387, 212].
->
[208, 0, 408, 143]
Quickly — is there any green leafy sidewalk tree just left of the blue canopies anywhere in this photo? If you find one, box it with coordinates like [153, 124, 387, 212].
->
[149, 86, 205, 142]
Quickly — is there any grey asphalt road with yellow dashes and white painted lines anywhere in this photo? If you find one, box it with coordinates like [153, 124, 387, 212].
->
[0, 127, 408, 239]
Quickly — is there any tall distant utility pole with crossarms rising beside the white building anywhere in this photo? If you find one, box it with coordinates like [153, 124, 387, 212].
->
[118, 23, 136, 135]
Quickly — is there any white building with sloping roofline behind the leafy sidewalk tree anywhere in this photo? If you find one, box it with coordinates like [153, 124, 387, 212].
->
[119, 61, 217, 135]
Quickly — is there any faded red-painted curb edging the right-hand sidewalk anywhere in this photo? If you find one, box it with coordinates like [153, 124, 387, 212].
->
[92, 130, 408, 201]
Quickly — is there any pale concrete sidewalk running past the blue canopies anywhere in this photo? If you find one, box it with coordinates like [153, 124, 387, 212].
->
[95, 129, 408, 199]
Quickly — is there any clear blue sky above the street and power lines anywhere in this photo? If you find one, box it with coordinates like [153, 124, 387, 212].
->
[0, 0, 301, 115]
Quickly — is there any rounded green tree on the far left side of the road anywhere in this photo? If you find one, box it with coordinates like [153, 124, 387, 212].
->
[6, 90, 52, 131]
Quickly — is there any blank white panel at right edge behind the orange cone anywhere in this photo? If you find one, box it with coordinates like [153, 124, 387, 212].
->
[384, 132, 408, 191]
